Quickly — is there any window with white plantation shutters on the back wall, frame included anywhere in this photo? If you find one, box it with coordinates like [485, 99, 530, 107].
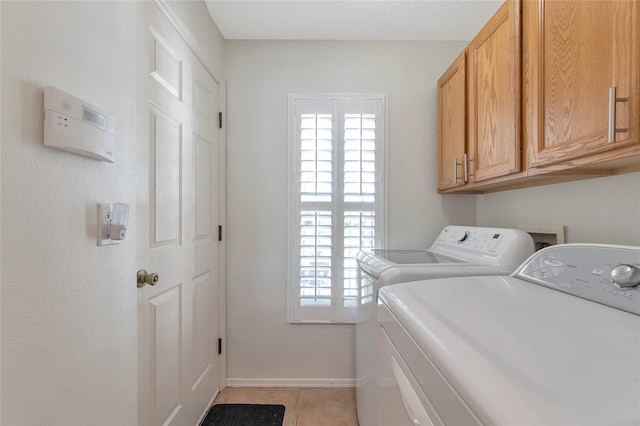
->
[288, 95, 386, 323]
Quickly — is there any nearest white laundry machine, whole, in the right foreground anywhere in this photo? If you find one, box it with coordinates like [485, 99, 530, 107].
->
[379, 244, 640, 426]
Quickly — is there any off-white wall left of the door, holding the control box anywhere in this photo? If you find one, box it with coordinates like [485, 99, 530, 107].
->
[1, 2, 137, 425]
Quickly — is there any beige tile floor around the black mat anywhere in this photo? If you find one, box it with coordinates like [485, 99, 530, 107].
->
[214, 387, 358, 426]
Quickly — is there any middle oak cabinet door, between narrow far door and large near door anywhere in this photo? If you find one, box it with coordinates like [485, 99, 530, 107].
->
[469, 0, 522, 182]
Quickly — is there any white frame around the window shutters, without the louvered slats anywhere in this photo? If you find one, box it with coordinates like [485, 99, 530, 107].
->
[287, 93, 388, 324]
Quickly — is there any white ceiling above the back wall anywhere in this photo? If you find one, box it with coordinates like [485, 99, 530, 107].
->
[205, 0, 503, 40]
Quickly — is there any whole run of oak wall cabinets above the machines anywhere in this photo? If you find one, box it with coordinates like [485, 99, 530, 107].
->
[438, 0, 640, 193]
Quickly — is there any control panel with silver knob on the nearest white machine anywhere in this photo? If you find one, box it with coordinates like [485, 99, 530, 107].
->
[515, 244, 640, 315]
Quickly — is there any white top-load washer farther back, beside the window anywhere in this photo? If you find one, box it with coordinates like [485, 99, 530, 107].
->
[356, 226, 534, 426]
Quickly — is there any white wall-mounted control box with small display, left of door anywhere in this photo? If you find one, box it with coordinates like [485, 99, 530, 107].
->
[44, 86, 115, 163]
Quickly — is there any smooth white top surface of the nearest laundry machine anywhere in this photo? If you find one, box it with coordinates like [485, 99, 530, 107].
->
[380, 277, 640, 425]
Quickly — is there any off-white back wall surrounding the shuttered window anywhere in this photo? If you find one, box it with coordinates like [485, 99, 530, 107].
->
[225, 41, 475, 383]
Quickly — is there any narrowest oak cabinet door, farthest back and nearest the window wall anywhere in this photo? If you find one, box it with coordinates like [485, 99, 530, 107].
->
[438, 52, 467, 190]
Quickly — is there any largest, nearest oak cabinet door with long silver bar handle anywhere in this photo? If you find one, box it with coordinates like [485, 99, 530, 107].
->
[523, 0, 640, 171]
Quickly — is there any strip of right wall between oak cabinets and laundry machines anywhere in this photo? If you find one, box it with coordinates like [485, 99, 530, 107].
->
[477, 173, 640, 246]
